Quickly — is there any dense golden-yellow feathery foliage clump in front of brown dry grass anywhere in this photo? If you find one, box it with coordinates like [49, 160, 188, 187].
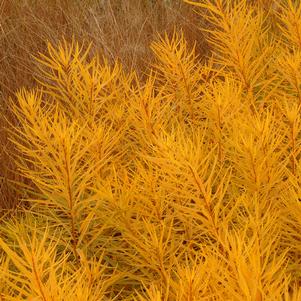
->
[0, 0, 301, 301]
